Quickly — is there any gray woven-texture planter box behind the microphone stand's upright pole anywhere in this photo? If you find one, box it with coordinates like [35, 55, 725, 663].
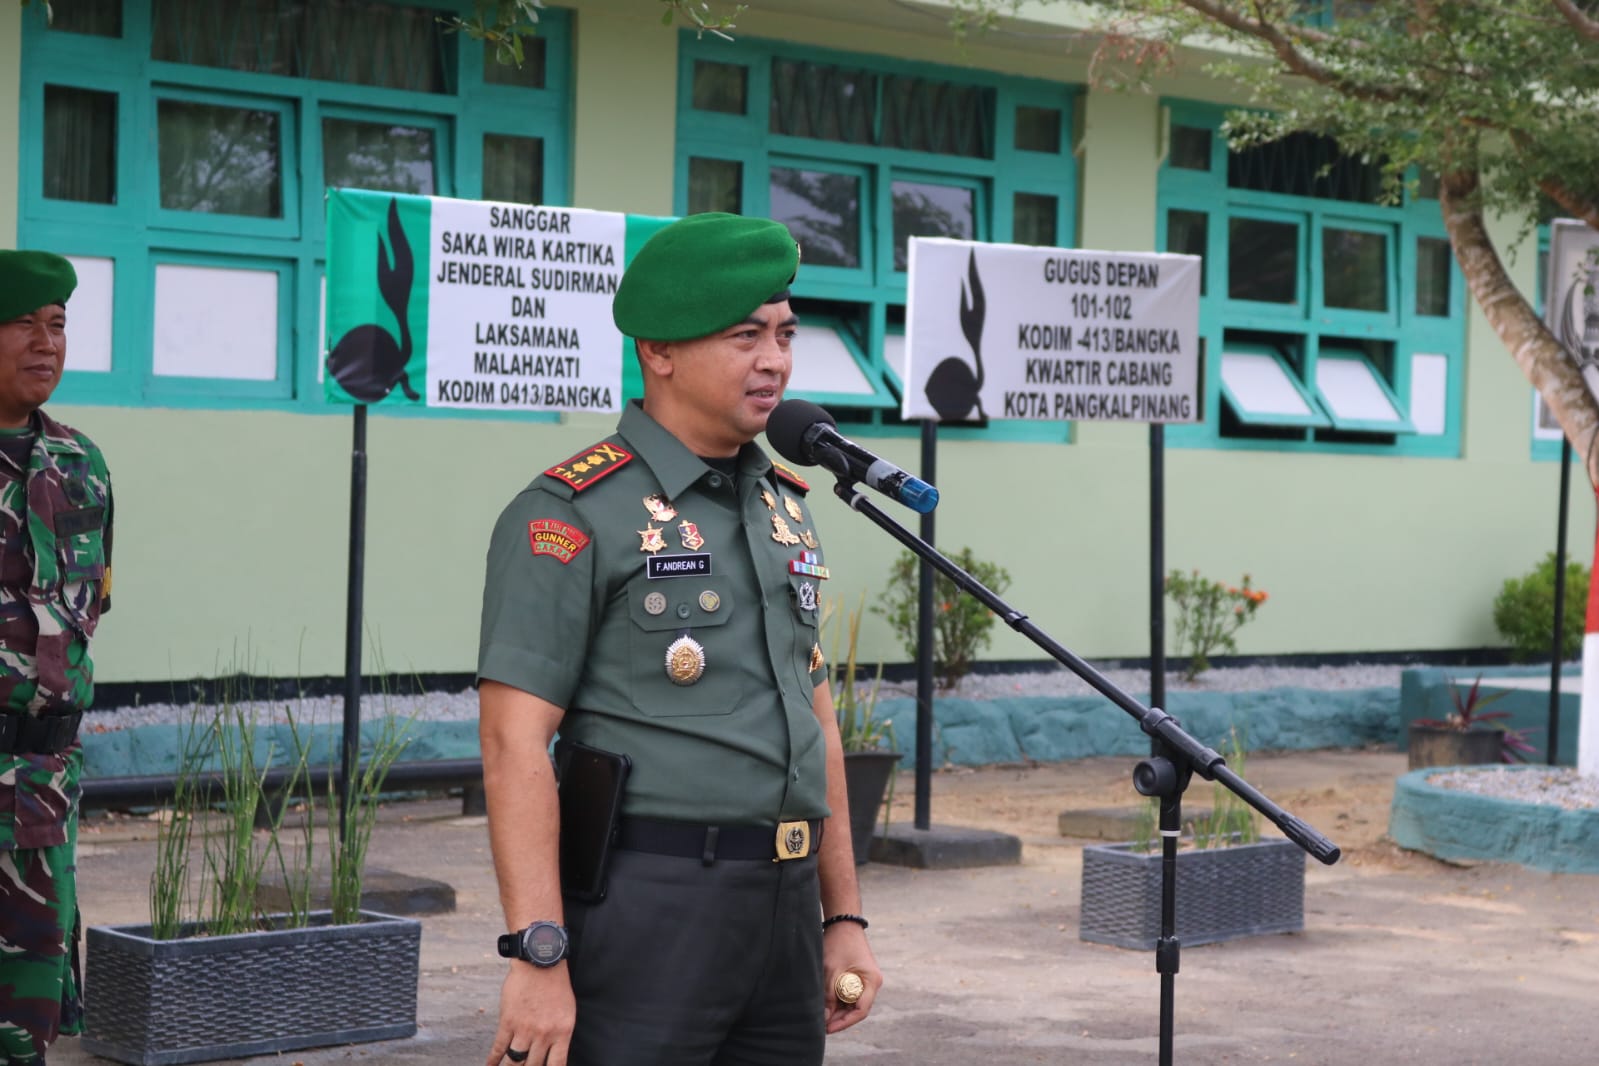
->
[1078, 837, 1305, 951]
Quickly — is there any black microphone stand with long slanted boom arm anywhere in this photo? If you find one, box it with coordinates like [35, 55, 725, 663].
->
[815, 473, 1340, 1066]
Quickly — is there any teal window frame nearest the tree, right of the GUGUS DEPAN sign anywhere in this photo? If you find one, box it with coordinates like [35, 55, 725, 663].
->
[1156, 99, 1466, 459]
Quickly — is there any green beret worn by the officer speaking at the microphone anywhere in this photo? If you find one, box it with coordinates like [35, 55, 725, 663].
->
[611, 211, 800, 340]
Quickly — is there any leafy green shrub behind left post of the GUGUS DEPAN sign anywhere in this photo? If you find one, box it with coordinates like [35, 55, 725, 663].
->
[871, 548, 1011, 690]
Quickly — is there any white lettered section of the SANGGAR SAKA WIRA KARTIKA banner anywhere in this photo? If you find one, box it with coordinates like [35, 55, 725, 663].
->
[427, 200, 627, 411]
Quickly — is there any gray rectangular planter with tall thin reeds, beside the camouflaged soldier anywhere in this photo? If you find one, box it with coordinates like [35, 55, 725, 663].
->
[83, 702, 422, 1066]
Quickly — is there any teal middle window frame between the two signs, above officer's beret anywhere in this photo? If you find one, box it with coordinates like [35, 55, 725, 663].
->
[673, 32, 1081, 441]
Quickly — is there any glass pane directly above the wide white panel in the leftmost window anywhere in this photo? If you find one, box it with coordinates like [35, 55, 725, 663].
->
[155, 99, 283, 219]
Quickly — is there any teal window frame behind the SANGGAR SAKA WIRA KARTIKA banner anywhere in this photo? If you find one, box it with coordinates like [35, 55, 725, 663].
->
[18, 0, 572, 422]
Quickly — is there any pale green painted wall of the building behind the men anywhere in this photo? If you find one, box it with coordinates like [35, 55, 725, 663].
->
[0, 0, 1594, 681]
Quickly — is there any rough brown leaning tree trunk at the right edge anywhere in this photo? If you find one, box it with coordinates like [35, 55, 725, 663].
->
[1439, 169, 1599, 486]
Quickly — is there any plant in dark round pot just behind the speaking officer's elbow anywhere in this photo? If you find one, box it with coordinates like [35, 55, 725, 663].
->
[823, 595, 903, 866]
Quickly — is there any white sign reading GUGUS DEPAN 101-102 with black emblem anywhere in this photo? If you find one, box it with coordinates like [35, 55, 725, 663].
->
[900, 237, 1201, 422]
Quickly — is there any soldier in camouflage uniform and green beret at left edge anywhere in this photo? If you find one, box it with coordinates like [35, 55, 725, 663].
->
[0, 251, 112, 1066]
